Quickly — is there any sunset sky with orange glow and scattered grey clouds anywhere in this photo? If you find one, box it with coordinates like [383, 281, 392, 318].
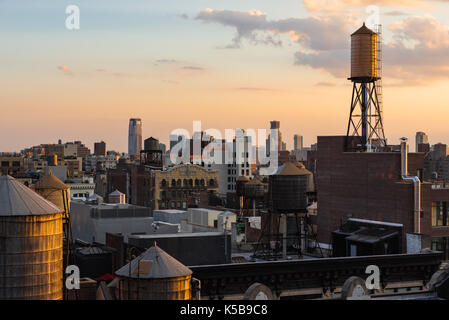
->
[0, 0, 449, 152]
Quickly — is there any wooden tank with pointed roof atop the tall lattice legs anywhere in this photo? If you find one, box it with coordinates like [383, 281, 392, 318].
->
[351, 24, 378, 80]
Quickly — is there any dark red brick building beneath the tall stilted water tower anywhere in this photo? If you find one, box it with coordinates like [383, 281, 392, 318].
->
[316, 136, 449, 255]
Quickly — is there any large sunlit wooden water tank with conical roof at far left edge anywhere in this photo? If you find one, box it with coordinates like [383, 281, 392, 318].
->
[0, 176, 63, 300]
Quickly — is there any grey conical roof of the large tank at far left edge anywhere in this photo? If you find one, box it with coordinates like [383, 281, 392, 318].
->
[0, 175, 62, 216]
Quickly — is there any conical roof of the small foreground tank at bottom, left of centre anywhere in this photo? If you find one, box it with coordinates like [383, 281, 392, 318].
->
[115, 245, 192, 279]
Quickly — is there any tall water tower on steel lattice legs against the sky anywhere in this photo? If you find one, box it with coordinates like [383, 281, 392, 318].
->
[346, 23, 386, 151]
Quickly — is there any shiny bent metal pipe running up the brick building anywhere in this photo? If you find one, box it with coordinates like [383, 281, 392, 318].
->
[401, 138, 421, 233]
